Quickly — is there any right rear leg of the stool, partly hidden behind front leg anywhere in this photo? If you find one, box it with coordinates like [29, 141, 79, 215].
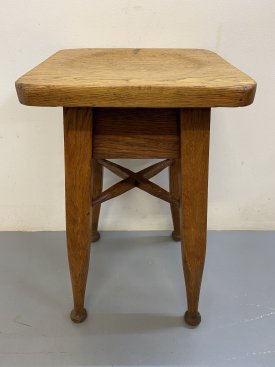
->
[169, 159, 181, 241]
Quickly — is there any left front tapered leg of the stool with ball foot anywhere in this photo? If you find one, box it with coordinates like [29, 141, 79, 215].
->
[64, 107, 92, 322]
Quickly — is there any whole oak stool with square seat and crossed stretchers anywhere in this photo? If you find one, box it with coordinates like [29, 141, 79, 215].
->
[16, 49, 256, 326]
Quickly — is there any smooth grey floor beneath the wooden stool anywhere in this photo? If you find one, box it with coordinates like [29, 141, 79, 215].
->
[0, 231, 275, 367]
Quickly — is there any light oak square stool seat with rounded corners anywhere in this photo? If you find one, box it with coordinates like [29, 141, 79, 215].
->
[16, 49, 256, 107]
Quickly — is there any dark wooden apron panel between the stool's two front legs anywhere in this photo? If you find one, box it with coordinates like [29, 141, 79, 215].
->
[93, 108, 179, 159]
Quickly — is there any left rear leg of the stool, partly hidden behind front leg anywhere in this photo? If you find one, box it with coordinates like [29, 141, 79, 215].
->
[91, 159, 103, 242]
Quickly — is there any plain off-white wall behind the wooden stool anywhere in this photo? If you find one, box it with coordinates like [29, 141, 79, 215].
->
[0, 0, 275, 230]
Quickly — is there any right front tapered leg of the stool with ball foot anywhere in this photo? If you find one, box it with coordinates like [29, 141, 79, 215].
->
[180, 108, 210, 326]
